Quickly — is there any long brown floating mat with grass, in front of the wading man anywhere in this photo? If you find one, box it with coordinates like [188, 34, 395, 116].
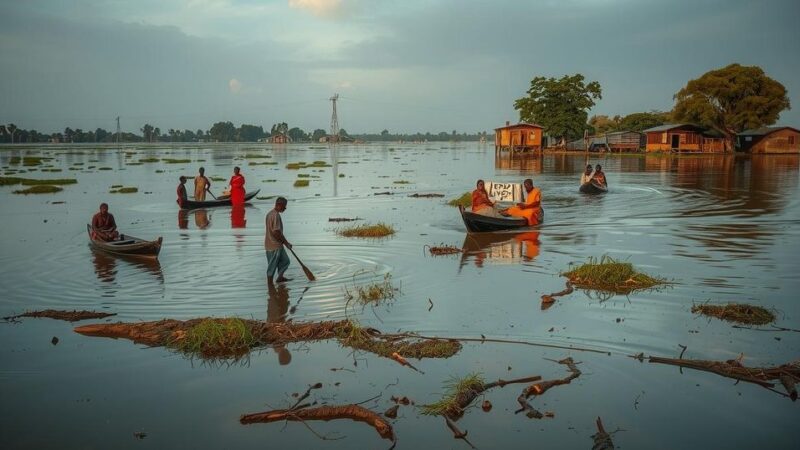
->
[75, 318, 461, 359]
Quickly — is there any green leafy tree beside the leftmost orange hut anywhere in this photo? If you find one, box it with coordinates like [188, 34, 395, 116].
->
[514, 73, 602, 140]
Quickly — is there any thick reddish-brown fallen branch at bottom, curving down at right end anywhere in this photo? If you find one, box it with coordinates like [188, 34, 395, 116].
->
[239, 405, 397, 448]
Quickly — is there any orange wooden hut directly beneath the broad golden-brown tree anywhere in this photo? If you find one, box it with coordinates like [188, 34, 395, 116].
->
[644, 123, 725, 153]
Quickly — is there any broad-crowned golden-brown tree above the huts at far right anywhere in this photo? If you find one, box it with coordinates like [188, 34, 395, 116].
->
[672, 64, 790, 149]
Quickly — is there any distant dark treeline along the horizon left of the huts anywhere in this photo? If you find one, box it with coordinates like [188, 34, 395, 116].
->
[0, 122, 487, 144]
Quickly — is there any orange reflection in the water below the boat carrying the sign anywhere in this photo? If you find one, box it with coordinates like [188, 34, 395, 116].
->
[459, 231, 541, 269]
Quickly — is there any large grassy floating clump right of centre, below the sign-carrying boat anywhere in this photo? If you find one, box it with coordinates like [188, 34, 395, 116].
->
[562, 255, 667, 294]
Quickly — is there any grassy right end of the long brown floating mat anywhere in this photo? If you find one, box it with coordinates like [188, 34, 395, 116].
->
[333, 321, 461, 359]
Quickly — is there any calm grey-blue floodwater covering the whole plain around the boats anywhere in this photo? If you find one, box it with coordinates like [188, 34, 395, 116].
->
[0, 143, 800, 449]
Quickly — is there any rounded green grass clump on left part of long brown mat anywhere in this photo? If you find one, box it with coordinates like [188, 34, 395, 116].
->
[168, 317, 258, 358]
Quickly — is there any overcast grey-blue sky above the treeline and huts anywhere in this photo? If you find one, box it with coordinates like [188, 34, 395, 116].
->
[0, 0, 800, 133]
